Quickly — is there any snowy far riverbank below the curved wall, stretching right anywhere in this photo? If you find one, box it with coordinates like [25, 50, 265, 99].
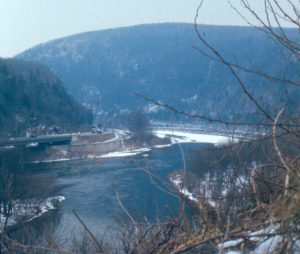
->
[30, 129, 238, 163]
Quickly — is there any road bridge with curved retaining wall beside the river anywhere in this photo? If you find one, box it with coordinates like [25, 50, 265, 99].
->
[0, 130, 128, 161]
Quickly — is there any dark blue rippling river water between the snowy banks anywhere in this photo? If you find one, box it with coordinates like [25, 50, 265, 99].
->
[23, 144, 208, 243]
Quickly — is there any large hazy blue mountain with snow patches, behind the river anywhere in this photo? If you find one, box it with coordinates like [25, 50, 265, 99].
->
[17, 24, 300, 124]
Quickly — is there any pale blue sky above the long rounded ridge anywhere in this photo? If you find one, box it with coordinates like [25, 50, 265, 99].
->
[0, 0, 296, 57]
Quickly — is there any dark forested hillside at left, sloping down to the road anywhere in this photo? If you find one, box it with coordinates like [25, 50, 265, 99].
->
[0, 59, 92, 136]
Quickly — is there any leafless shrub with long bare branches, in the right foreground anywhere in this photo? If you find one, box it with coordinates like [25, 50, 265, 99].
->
[132, 0, 300, 253]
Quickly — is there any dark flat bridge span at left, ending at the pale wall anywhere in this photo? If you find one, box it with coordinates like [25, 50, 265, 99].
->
[0, 134, 72, 147]
